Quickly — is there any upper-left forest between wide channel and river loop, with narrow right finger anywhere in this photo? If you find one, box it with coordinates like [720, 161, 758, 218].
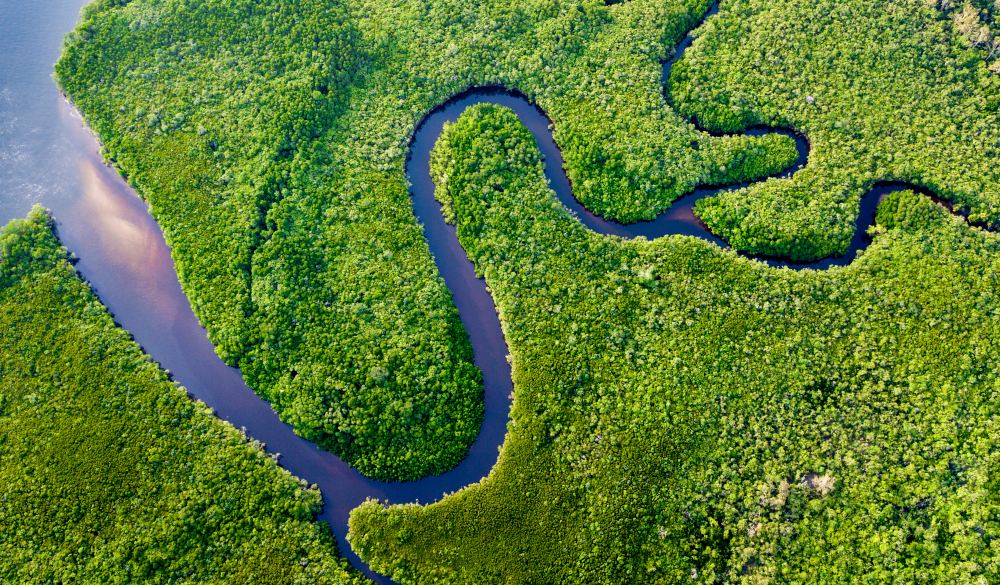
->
[57, 0, 796, 479]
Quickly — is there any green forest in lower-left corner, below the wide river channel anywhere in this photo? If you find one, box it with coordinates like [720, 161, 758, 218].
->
[0, 208, 360, 584]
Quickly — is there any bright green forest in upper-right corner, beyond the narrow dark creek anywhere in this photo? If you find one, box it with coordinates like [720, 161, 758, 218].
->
[670, 0, 1000, 260]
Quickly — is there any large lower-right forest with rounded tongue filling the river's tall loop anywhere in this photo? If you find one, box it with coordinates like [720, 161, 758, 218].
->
[350, 106, 1000, 584]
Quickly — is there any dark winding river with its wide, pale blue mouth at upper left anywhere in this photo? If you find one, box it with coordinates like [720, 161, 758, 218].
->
[0, 0, 984, 583]
